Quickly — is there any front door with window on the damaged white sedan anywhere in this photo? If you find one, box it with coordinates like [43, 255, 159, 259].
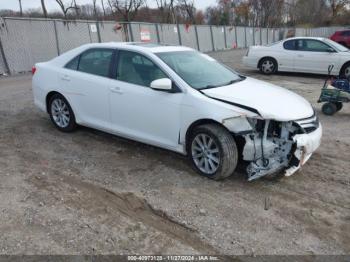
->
[110, 51, 183, 149]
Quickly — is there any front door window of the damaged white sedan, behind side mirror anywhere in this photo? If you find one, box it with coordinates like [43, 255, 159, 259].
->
[116, 51, 168, 87]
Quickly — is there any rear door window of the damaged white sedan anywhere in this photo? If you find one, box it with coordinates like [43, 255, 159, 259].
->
[78, 49, 113, 76]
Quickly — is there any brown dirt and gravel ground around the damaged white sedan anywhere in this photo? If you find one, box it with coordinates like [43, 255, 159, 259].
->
[0, 50, 350, 255]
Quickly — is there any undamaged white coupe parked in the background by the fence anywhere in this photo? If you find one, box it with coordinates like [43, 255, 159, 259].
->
[243, 37, 350, 77]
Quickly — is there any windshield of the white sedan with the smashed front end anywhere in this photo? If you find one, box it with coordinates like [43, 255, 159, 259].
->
[156, 51, 244, 90]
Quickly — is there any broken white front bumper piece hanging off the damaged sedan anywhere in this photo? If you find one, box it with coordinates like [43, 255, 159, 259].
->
[285, 123, 322, 176]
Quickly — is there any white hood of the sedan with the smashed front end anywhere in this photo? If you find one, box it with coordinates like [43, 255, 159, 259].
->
[202, 77, 314, 121]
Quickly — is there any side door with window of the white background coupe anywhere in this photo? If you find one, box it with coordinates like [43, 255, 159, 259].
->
[294, 39, 339, 74]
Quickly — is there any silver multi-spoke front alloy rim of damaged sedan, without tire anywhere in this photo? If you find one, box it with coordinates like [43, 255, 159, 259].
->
[191, 133, 220, 175]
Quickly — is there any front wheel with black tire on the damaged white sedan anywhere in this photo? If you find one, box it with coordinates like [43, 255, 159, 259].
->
[187, 124, 238, 180]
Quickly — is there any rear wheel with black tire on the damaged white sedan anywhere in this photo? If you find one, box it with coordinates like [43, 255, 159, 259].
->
[48, 94, 77, 132]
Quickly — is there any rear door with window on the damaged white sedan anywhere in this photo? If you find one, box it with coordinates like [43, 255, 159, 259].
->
[59, 48, 115, 130]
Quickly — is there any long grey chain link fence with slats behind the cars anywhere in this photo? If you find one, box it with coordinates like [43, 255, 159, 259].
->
[0, 17, 348, 74]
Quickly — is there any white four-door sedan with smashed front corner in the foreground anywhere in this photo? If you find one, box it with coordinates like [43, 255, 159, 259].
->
[33, 43, 322, 180]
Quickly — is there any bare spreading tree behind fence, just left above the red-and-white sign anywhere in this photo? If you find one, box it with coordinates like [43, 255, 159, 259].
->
[111, 0, 146, 22]
